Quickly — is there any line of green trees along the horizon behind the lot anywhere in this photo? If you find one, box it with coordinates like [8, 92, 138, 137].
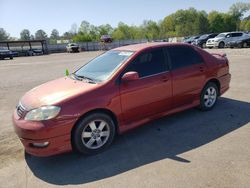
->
[0, 2, 250, 43]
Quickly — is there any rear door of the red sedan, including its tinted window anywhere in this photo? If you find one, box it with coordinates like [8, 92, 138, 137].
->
[166, 46, 207, 108]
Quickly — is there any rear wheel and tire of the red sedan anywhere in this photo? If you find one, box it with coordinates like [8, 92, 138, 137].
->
[199, 82, 219, 111]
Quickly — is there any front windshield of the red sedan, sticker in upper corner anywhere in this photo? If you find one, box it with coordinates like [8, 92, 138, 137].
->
[74, 50, 133, 82]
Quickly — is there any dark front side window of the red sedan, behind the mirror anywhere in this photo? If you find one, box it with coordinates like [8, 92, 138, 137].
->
[125, 48, 167, 77]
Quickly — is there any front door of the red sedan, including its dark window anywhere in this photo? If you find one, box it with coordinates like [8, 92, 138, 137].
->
[120, 48, 172, 122]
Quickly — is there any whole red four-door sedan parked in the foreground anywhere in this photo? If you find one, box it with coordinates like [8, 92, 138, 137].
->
[13, 43, 231, 156]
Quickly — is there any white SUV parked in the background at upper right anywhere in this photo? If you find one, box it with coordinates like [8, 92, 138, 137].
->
[206, 32, 249, 48]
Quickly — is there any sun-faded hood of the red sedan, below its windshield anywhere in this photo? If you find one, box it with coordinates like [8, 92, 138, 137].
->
[20, 77, 99, 110]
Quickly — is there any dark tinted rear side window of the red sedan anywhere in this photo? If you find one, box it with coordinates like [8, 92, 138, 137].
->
[167, 46, 203, 70]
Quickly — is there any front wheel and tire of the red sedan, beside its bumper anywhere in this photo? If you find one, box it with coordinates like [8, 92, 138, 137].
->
[71, 113, 116, 155]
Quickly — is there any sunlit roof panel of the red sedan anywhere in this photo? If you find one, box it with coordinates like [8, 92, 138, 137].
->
[113, 42, 191, 51]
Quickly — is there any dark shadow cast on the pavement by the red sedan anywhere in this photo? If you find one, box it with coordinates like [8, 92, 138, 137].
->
[25, 98, 250, 185]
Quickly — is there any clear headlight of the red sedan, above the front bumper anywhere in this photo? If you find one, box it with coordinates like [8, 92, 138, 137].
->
[24, 106, 61, 121]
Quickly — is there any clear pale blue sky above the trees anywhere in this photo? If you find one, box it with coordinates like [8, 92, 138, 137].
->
[0, 0, 250, 37]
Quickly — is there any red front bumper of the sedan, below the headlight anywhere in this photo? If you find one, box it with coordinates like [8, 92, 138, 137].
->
[12, 110, 76, 157]
